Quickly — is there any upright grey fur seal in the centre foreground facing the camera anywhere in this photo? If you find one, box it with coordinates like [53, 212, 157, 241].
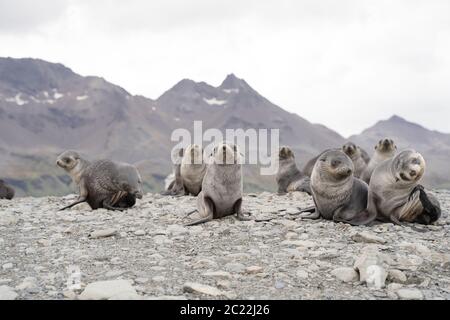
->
[186, 142, 247, 226]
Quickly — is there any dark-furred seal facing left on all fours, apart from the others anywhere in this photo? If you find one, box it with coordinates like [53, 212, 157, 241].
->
[56, 151, 142, 210]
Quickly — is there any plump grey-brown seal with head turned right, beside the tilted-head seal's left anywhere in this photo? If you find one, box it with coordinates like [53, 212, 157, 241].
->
[300, 150, 376, 225]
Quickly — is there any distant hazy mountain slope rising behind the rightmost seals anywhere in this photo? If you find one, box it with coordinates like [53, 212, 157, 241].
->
[349, 116, 450, 189]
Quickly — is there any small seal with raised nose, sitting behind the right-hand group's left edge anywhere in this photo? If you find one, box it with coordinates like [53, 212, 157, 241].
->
[275, 146, 311, 195]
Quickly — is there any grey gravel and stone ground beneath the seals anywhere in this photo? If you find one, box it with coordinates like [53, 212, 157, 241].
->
[0, 191, 450, 299]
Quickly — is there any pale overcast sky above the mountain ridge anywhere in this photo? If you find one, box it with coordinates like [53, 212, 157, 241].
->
[0, 0, 450, 136]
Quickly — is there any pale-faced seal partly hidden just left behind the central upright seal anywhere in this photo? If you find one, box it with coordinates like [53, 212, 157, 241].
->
[180, 144, 206, 196]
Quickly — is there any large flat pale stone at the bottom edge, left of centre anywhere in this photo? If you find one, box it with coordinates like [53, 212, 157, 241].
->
[79, 280, 140, 300]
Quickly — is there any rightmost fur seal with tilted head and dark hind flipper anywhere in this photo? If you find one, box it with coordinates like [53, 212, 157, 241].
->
[367, 149, 441, 226]
